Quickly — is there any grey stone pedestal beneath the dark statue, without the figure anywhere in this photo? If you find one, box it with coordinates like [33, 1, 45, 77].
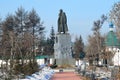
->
[54, 33, 75, 65]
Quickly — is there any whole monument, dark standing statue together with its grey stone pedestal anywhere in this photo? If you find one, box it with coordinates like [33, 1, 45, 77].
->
[54, 9, 75, 66]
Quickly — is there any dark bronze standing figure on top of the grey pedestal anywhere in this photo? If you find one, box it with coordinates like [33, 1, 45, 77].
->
[58, 9, 68, 33]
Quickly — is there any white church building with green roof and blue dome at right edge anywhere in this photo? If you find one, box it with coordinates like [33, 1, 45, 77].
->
[103, 23, 120, 65]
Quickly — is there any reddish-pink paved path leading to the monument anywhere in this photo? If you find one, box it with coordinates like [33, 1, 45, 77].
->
[51, 72, 82, 80]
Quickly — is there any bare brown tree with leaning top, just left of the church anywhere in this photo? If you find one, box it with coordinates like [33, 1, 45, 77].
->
[87, 15, 107, 64]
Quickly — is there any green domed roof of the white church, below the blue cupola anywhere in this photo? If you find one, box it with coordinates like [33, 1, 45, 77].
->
[105, 31, 120, 47]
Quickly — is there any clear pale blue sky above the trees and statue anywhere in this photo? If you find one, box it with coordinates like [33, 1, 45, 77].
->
[0, 0, 119, 42]
